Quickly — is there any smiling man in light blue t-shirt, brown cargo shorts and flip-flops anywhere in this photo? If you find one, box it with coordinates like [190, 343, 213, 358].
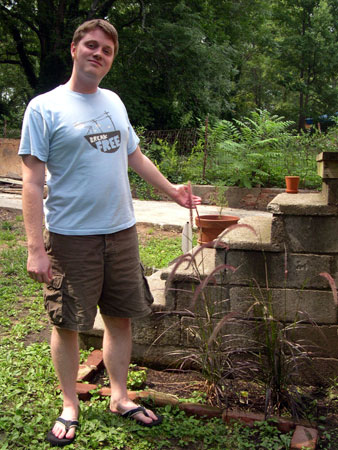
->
[19, 19, 200, 446]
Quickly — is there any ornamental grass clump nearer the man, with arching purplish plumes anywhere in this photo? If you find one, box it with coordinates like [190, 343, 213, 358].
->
[167, 214, 254, 406]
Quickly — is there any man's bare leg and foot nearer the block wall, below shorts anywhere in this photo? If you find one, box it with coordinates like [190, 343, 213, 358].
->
[102, 315, 157, 423]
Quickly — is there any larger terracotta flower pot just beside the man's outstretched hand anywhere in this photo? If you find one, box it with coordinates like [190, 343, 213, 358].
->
[195, 214, 240, 244]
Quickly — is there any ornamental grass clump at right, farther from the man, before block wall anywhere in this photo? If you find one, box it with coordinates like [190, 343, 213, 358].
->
[249, 257, 338, 420]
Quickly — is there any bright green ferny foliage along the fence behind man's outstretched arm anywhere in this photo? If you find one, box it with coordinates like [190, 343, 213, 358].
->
[129, 110, 338, 192]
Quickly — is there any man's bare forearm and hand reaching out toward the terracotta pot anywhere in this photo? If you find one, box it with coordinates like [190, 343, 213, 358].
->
[128, 147, 201, 208]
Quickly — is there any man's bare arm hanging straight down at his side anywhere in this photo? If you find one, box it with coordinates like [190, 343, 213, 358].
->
[22, 155, 53, 283]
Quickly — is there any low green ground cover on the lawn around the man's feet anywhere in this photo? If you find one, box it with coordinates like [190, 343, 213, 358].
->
[0, 214, 296, 450]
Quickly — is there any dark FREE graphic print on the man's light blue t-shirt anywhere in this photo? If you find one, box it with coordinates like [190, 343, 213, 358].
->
[74, 111, 121, 153]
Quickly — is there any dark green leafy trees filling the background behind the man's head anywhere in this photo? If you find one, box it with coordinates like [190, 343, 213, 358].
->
[0, 0, 338, 129]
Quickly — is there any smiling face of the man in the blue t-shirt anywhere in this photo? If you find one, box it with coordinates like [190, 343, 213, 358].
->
[71, 28, 114, 84]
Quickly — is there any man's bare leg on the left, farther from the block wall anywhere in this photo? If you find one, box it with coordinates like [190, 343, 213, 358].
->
[51, 327, 79, 439]
